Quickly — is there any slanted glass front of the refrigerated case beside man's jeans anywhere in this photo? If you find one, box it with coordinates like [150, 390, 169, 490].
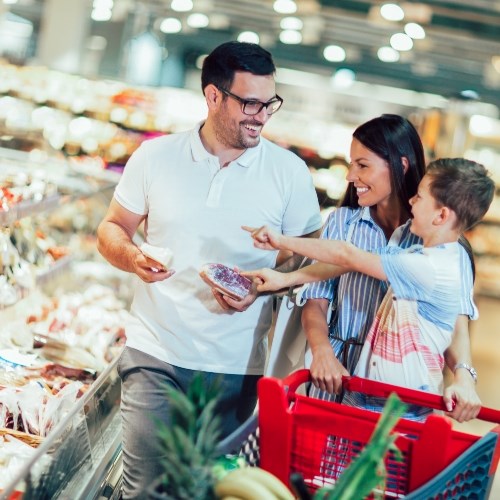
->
[0, 357, 121, 500]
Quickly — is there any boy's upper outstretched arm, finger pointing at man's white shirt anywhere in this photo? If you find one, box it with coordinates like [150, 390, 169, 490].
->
[243, 226, 387, 281]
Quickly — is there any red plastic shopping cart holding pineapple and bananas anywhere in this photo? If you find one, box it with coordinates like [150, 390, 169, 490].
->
[258, 370, 500, 500]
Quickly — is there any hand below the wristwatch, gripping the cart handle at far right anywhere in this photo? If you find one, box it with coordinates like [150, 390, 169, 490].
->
[443, 370, 481, 422]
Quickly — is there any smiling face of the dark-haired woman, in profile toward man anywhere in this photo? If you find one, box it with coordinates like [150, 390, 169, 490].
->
[347, 138, 392, 207]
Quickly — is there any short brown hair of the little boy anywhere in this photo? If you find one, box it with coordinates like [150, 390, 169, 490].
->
[427, 158, 495, 231]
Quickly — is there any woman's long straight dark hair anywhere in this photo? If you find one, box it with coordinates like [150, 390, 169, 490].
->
[340, 114, 425, 213]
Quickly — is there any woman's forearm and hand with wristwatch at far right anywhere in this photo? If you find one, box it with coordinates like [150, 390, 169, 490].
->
[443, 314, 481, 422]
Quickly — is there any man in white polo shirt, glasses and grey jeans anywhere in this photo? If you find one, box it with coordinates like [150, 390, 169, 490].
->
[98, 42, 321, 498]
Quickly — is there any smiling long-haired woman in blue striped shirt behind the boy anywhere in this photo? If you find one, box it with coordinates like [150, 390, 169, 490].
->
[302, 115, 480, 422]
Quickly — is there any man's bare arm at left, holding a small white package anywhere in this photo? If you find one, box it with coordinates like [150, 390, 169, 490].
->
[97, 198, 174, 283]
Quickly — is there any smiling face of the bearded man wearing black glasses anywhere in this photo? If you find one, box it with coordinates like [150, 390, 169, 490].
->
[213, 71, 276, 149]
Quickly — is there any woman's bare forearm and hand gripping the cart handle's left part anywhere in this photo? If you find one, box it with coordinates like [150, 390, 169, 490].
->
[302, 299, 349, 394]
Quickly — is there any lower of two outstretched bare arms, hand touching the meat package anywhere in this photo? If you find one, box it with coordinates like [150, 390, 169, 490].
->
[240, 262, 344, 292]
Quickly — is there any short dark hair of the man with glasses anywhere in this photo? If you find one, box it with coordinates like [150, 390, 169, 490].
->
[201, 41, 276, 91]
